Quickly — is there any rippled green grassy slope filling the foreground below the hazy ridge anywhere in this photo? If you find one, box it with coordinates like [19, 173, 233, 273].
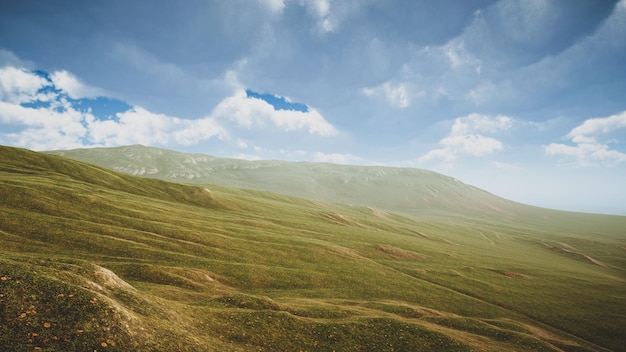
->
[0, 147, 626, 351]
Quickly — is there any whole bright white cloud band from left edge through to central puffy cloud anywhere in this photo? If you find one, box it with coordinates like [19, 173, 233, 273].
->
[0, 66, 337, 150]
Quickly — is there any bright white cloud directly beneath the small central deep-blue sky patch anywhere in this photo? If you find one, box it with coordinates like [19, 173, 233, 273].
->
[212, 89, 337, 136]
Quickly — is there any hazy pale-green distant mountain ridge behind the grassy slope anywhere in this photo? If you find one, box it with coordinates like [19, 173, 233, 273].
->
[48, 145, 522, 217]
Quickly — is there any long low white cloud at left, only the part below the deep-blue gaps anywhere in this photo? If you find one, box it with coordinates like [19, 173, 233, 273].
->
[0, 102, 228, 150]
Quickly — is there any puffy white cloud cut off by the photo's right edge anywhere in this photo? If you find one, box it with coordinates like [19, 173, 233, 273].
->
[545, 111, 626, 166]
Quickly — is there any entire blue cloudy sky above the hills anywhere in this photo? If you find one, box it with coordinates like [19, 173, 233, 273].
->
[0, 0, 626, 215]
